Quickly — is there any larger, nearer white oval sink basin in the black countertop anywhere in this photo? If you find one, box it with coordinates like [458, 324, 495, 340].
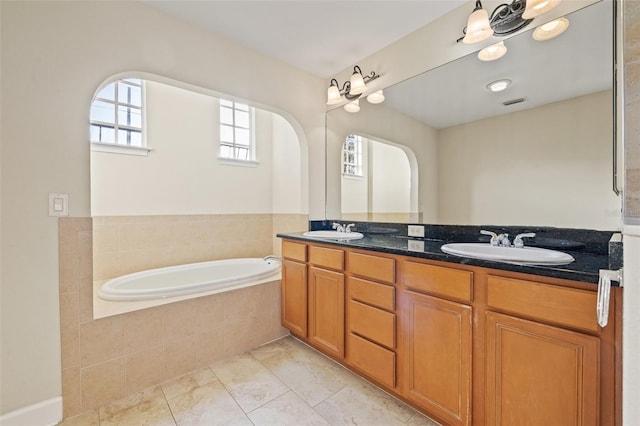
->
[441, 243, 575, 265]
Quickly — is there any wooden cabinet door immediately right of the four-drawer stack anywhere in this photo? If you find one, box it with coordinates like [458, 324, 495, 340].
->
[400, 291, 472, 425]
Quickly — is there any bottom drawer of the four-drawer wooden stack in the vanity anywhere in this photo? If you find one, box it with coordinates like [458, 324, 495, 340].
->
[347, 333, 396, 388]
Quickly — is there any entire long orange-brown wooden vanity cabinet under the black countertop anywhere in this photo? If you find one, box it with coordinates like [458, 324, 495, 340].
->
[282, 239, 622, 426]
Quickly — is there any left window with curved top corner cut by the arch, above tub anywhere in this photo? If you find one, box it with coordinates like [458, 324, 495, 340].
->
[90, 78, 145, 148]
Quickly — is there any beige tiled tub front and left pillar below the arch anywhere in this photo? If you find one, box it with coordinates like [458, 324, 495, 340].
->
[59, 218, 286, 421]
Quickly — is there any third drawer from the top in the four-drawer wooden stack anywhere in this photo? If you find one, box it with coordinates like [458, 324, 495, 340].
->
[349, 300, 396, 349]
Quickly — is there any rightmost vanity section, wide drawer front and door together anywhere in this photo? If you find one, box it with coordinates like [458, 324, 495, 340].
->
[485, 275, 613, 425]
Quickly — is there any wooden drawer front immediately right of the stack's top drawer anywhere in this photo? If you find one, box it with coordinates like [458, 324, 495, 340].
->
[403, 262, 473, 302]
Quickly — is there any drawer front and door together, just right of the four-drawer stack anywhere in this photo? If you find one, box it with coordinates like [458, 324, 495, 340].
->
[399, 261, 473, 425]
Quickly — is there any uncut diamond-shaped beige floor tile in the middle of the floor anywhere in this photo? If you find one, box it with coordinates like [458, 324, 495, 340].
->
[211, 354, 289, 413]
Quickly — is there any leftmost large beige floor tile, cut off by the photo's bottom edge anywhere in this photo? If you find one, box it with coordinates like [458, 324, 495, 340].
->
[100, 386, 176, 426]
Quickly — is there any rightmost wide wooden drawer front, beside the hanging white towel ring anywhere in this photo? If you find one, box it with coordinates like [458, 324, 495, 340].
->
[487, 275, 600, 331]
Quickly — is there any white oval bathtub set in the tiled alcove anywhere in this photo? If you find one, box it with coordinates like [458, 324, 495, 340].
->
[98, 256, 281, 302]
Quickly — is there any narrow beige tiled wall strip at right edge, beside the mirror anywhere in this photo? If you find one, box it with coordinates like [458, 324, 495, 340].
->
[623, 1, 640, 220]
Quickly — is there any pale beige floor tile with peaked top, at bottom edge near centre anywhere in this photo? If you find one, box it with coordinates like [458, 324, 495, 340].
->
[248, 391, 329, 426]
